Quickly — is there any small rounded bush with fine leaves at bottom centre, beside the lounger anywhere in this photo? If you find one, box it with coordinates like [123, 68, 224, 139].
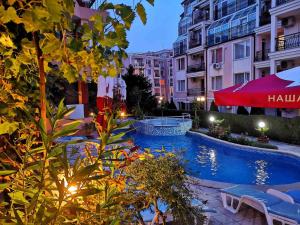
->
[126, 150, 203, 225]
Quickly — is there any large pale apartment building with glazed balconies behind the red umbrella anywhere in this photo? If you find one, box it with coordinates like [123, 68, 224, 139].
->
[173, 0, 300, 116]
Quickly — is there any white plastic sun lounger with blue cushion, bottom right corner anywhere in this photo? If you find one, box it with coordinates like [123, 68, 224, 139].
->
[221, 185, 300, 225]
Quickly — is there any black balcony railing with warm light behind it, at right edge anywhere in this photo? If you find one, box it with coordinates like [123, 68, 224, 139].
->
[276, 32, 300, 51]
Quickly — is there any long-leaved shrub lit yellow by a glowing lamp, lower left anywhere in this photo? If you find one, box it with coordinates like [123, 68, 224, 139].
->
[0, 102, 149, 224]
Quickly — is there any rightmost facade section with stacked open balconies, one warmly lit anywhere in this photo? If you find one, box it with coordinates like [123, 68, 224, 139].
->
[254, 0, 300, 117]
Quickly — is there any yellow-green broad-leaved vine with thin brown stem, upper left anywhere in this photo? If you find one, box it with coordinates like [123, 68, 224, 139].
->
[0, 0, 154, 126]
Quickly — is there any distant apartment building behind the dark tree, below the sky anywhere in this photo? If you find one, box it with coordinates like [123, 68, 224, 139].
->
[122, 50, 174, 102]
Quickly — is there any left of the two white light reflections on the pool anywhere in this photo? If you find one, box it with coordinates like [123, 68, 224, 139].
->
[197, 146, 218, 176]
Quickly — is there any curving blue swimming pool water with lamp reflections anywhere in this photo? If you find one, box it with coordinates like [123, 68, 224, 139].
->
[130, 133, 300, 185]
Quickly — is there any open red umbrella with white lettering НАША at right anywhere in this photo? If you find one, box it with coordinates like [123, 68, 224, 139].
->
[214, 67, 300, 109]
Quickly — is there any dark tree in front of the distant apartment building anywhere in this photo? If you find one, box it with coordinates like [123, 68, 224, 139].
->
[123, 65, 157, 116]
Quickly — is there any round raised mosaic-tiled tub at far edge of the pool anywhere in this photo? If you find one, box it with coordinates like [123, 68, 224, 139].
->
[134, 114, 192, 136]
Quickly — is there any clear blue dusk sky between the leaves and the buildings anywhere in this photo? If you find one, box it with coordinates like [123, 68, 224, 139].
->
[113, 0, 183, 52]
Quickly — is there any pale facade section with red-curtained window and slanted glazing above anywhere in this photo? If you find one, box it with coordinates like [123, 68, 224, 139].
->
[207, 0, 257, 113]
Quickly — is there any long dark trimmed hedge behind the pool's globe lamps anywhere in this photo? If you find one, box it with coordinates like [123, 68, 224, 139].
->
[153, 110, 300, 144]
